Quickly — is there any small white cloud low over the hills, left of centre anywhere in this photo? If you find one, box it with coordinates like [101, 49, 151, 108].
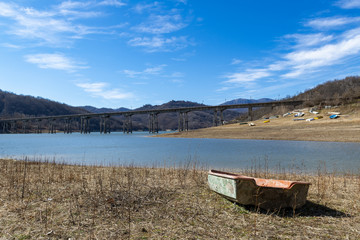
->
[76, 82, 134, 100]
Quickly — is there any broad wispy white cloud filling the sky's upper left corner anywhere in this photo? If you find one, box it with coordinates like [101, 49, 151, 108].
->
[0, 1, 122, 47]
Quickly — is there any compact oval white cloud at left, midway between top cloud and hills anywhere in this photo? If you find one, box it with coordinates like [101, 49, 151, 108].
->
[25, 53, 88, 72]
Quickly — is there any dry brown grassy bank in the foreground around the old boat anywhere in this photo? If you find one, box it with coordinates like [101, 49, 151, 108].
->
[0, 160, 360, 239]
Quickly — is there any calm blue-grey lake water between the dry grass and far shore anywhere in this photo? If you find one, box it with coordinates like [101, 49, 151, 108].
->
[0, 133, 360, 172]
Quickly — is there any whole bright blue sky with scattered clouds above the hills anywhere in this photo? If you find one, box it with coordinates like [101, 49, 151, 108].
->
[0, 0, 360, 108]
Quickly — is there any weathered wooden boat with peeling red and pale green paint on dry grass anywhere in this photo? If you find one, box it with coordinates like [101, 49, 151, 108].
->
[208, 170, 310, 210]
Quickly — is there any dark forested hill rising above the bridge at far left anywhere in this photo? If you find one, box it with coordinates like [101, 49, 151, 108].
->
[0, 90, 88, 117]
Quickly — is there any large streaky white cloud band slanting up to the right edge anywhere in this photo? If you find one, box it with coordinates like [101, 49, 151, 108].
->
[222, 4, 360, 90]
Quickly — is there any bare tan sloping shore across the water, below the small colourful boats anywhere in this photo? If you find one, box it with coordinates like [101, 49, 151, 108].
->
[160, 109, 360, 142]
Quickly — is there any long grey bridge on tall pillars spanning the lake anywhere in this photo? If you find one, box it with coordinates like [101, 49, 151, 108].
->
[0, 100, 305, 134]
